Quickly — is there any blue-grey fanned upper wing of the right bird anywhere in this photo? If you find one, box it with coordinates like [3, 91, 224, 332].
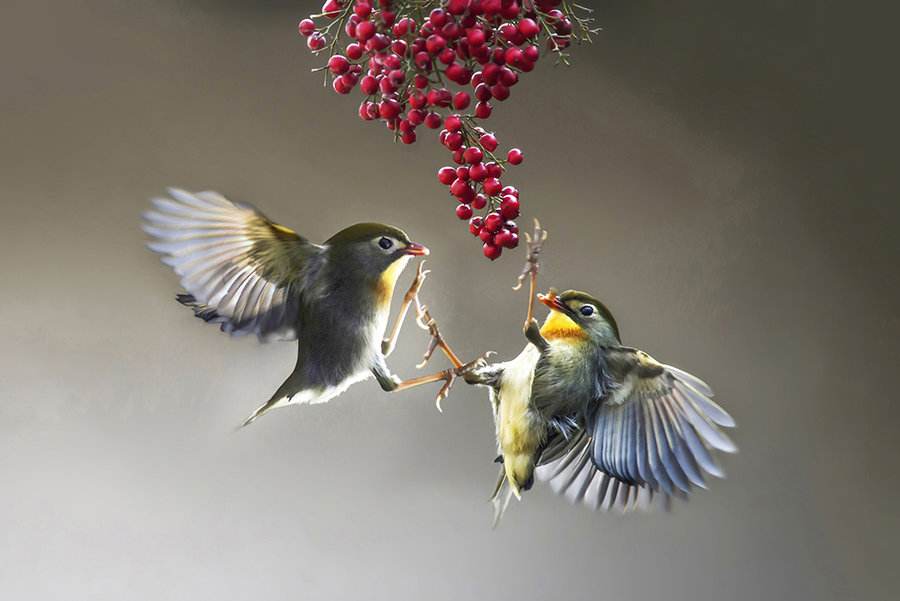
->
[589, 347, 737, 495]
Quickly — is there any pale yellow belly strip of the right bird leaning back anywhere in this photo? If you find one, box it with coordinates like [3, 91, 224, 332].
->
[496, 344, 543, 490]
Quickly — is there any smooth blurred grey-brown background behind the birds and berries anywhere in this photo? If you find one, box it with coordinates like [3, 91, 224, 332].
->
[0, 0, 900, 601]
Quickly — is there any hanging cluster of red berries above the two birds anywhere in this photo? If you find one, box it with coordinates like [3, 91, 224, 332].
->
[299, 0, 595, 260]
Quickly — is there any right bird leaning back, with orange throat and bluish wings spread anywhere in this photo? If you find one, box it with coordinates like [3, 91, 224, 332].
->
[465, 289, 737, 523]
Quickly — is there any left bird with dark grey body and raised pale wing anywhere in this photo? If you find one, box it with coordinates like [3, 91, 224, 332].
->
[143, 189, 448, 425]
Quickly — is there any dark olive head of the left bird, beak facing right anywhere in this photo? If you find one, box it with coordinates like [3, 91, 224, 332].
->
[325, 223, 428, 301]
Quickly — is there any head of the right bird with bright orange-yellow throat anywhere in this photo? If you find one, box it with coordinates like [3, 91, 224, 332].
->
[538, 288, 620, 344]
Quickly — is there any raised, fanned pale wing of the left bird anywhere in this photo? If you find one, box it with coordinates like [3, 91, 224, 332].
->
[143, 189, 324, 341]
